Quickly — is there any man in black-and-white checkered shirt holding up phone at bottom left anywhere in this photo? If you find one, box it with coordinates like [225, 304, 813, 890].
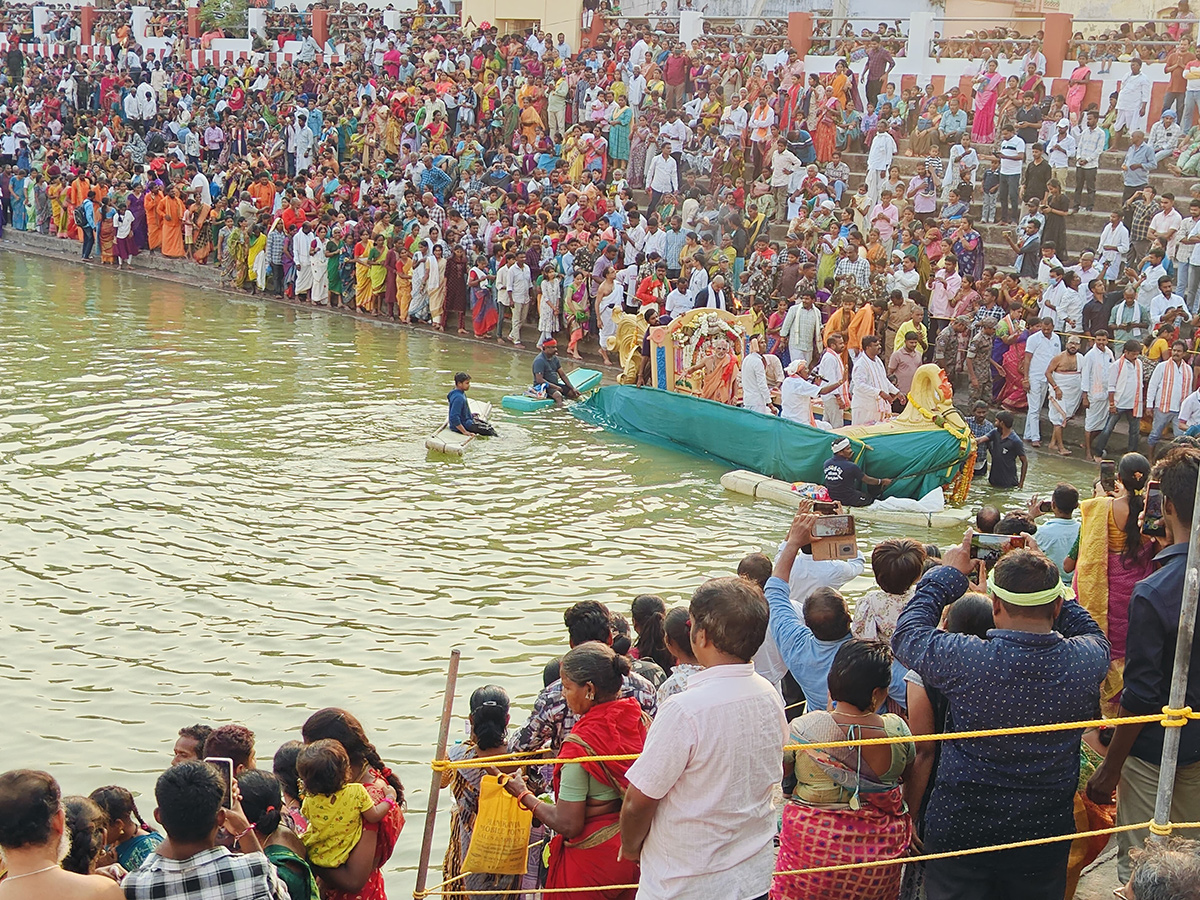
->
[121, 761, 289, 900]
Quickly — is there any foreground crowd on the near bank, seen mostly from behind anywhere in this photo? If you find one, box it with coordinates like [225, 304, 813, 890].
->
[0, 448, 1200, 900]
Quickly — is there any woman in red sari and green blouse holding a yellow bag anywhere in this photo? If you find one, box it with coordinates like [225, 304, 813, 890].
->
[496, 641, 649, 900]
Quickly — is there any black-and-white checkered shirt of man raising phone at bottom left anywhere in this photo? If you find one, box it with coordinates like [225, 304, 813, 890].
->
[121, 847, 288, 900]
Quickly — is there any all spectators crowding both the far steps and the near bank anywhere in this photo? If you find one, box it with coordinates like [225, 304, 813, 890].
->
[0, 10, 1200, 900]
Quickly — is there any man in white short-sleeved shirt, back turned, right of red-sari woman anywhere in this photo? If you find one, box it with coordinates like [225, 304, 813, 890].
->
[620, 573, 792, 900]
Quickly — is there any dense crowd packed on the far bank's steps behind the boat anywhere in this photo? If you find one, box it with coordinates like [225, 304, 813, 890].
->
[11, 5, 1200, 455]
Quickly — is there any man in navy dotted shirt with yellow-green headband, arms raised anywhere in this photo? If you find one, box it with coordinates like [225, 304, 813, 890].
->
[892, 532, 1109, 900]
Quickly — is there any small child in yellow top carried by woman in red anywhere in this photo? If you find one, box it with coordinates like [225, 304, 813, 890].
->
[296, 740, 396, 869]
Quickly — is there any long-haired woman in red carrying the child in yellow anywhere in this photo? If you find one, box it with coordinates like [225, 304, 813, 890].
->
[300, 707, 404, 900]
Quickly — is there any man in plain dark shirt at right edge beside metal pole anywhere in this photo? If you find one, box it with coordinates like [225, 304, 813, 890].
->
[1087, 448, 1200, 883]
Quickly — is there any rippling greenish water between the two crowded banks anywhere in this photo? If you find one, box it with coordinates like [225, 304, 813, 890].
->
[0, 252, 1093, 883]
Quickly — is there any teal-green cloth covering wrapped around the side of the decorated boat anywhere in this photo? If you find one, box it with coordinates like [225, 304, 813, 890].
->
[571, 385, 964, 499]
